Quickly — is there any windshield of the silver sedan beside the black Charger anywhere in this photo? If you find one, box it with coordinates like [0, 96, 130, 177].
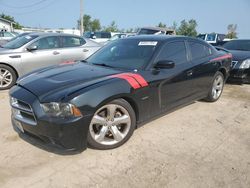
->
[2, 35, 38, 49]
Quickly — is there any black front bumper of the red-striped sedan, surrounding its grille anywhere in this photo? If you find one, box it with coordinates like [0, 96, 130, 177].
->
[10, 86, 91, 151]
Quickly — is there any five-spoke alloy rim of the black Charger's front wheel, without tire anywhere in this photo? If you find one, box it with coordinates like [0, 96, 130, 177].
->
[89, 104, 131, 145]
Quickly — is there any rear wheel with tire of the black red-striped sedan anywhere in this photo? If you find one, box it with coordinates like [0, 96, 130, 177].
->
[205, 72, 225, 102]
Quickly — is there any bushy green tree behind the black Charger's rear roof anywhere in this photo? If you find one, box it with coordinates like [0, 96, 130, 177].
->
[176, 19, 198, 37]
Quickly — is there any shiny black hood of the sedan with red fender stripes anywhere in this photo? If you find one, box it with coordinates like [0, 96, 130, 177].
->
[17, 62, 121, 102]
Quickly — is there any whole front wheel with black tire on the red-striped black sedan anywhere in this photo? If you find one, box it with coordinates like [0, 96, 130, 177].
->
[87, 99, 136, 150]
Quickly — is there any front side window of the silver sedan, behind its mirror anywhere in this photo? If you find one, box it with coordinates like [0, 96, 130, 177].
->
[32, 37, 59, 50]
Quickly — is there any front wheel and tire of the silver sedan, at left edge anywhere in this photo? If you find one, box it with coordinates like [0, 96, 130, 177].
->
[0, 64, 17, 90]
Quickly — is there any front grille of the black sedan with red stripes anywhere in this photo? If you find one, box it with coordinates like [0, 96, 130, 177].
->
[10, 97, 37, 125]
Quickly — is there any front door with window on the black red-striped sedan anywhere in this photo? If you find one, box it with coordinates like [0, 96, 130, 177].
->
[152, 40, 193, 111]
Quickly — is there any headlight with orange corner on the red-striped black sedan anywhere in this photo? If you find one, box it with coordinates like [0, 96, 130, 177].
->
[41, 102, 82, 118]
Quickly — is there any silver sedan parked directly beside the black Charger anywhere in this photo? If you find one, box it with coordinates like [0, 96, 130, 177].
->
[0, 33, 101, 90]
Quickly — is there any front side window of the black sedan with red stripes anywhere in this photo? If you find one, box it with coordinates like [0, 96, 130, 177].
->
[158, 41, 187, 64]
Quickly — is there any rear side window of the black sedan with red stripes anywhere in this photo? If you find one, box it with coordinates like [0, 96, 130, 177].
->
[189, 42, 212, 60]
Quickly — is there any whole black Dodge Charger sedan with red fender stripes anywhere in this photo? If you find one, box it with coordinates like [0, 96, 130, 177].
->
[10, 36, 231, 151]
